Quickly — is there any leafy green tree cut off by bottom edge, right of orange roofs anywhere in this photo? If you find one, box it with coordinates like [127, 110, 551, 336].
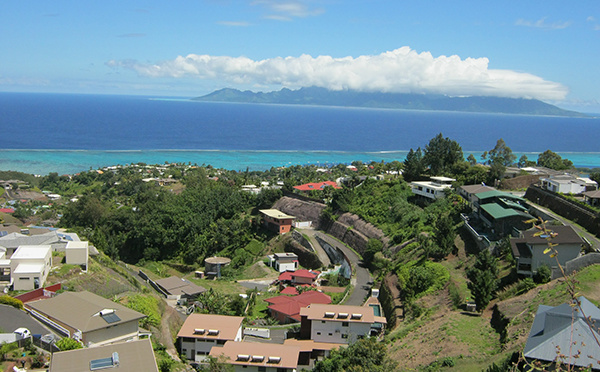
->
[313, 337, 397, 372]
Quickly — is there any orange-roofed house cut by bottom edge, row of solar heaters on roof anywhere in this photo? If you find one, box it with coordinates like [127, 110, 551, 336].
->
[210, 341, 300, 372]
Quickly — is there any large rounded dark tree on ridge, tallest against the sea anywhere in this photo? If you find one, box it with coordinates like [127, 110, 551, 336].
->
[423, 133, 464, 175]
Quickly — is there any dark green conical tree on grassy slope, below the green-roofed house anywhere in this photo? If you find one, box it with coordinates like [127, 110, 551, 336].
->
[466, 249, 498, 311]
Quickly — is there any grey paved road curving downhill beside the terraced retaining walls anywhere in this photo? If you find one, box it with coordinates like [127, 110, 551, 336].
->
[302, 230, 373, 306]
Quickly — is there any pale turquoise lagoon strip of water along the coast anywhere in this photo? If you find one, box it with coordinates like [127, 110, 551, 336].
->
[0, 149, 600, 175]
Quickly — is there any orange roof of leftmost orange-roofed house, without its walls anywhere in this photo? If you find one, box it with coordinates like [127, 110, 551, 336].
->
[177, 314, 244, 341]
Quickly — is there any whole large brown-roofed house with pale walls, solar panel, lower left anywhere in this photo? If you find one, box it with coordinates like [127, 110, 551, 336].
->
[25, 291, 146, 347]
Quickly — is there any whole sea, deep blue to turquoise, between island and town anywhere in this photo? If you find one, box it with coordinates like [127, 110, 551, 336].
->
[0, 93, 600, 174]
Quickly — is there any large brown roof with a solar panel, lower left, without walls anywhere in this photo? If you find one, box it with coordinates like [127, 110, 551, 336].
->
[25, 291, 146, 332]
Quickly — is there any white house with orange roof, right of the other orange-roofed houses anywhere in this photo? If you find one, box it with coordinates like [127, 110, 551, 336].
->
[300, 304, 387, 344]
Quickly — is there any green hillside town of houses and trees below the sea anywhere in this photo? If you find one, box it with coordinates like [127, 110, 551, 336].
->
[0, 143, 600, 372]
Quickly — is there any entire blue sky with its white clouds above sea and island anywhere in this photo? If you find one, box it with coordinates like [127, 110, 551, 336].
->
[0, 0, 600, 112]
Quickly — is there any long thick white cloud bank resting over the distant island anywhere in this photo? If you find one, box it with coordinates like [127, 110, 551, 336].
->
[107, 47, 568, 100]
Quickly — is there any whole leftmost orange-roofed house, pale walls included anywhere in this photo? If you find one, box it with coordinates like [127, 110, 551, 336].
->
[177, 314, 244, 362]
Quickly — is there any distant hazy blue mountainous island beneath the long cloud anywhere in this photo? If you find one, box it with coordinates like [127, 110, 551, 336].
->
[192, 87, 586, 117]
